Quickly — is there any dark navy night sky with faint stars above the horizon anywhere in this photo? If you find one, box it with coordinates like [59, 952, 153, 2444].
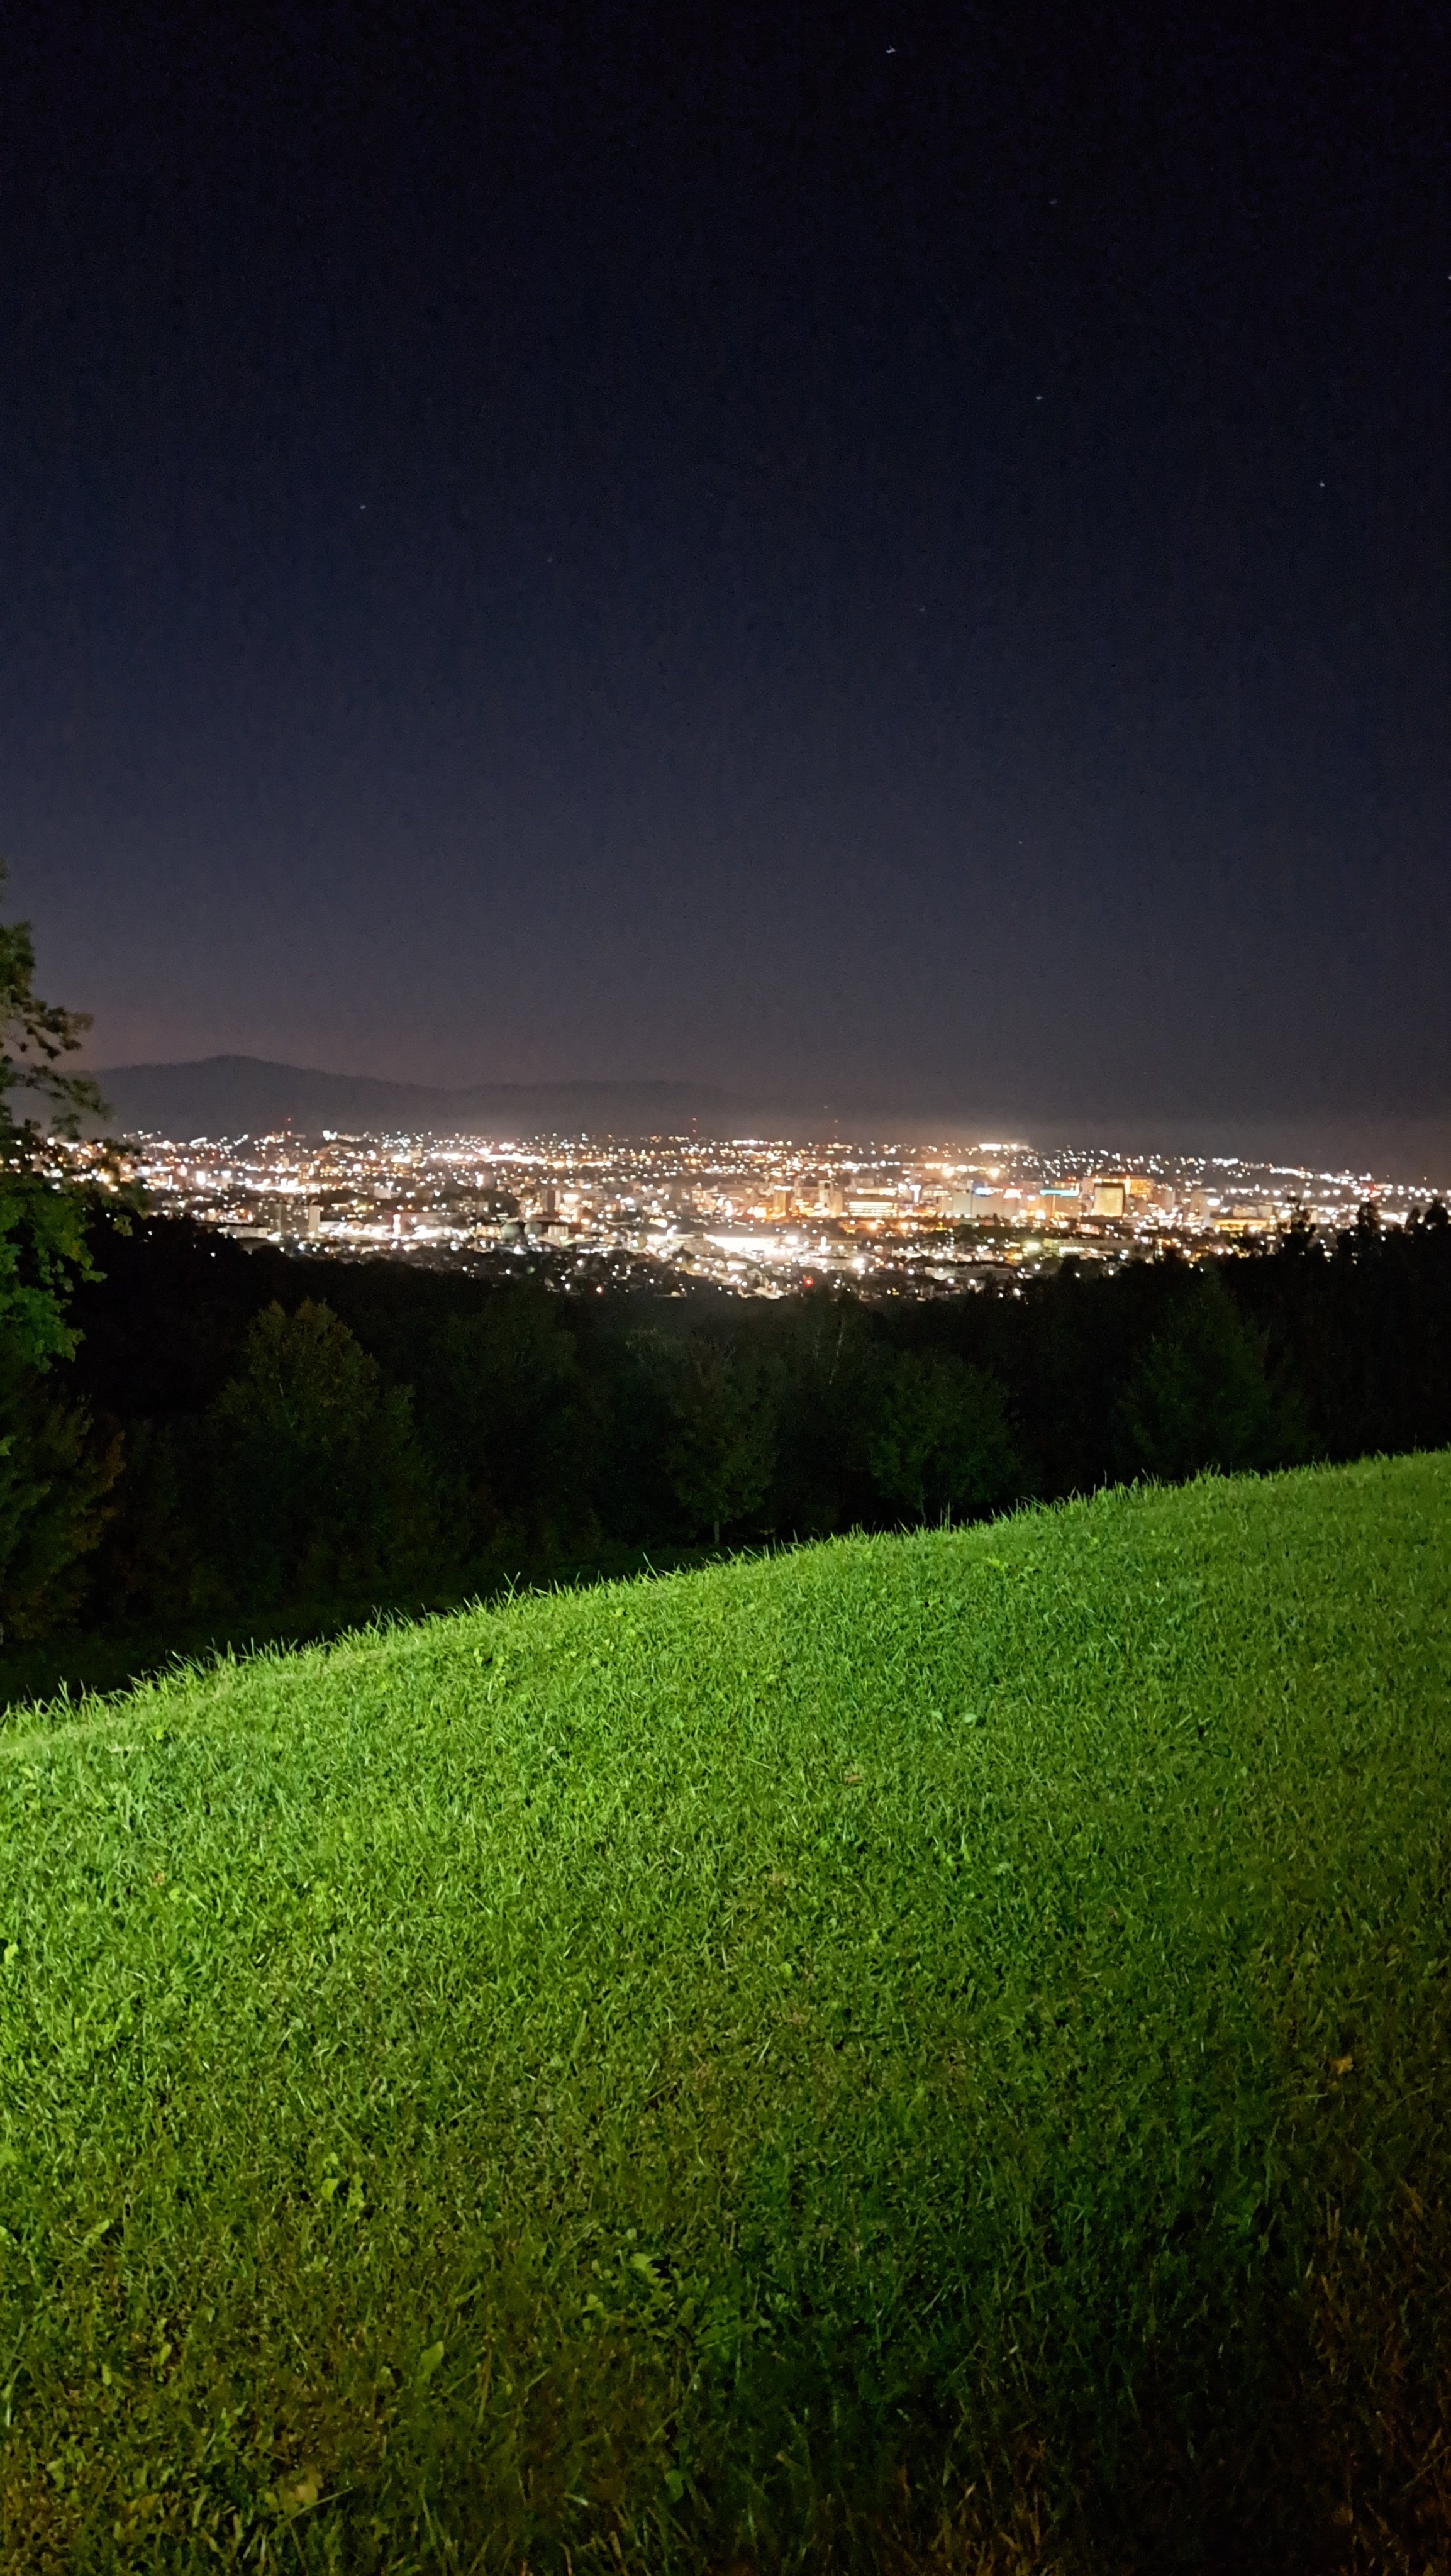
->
[0, 0, 1451, 1148]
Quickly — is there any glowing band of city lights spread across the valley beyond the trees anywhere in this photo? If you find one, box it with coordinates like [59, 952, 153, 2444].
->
[57, 1133, 1433, 1296]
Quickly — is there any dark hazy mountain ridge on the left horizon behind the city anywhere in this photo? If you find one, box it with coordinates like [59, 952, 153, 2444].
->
[96, 1056, 732, 1136]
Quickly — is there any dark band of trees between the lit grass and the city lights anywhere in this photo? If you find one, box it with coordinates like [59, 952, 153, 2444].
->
[0, 1208, 1451, 1636]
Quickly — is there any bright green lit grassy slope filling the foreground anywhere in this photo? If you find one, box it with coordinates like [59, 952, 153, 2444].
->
[0, 1455, 1451, 2576]
